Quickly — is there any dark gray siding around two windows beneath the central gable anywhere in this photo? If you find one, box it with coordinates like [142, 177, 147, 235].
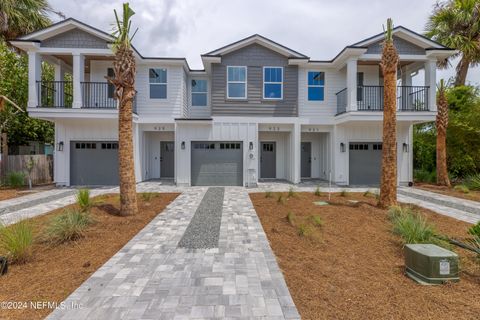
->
[212, 44, 298, 117]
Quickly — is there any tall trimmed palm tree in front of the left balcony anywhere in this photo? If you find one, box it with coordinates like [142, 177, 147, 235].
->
[107, 3, 137, 215]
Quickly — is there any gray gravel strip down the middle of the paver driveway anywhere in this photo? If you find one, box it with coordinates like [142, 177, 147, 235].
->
[178, 187, 225, 249]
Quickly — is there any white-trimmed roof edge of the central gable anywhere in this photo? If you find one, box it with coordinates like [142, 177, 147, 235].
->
[202, 34, 308, 59]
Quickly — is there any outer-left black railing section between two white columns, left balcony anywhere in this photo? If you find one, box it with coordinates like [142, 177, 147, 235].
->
[37, 81, 73, 108]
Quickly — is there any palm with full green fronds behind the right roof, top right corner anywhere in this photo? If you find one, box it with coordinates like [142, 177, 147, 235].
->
[426, 0, 480, 86]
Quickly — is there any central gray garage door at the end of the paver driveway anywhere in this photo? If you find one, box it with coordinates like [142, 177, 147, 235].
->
[192, 141, 243, 186]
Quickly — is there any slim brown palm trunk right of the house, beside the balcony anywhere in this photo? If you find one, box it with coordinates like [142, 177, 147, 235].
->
[435, 79, 450, 187]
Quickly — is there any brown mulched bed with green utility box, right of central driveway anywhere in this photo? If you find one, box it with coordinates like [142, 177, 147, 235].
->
[250, 193, 480, 319]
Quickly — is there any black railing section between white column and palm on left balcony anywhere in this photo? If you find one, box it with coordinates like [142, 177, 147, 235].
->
[81, 82, 117, 109]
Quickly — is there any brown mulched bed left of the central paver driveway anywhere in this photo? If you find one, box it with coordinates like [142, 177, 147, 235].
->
[0, 193, 178, 319]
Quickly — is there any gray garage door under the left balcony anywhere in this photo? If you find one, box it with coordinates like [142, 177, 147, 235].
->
[70, 141, 118, 185]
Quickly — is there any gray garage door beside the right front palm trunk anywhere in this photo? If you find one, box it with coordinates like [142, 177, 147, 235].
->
[349, 142, 382, 185]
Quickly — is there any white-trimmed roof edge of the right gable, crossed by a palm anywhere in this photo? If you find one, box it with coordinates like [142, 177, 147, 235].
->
[352, 26, 452, 50]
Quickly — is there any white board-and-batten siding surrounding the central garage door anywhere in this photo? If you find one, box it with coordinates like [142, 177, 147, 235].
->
[175, 122, 258, 185]
